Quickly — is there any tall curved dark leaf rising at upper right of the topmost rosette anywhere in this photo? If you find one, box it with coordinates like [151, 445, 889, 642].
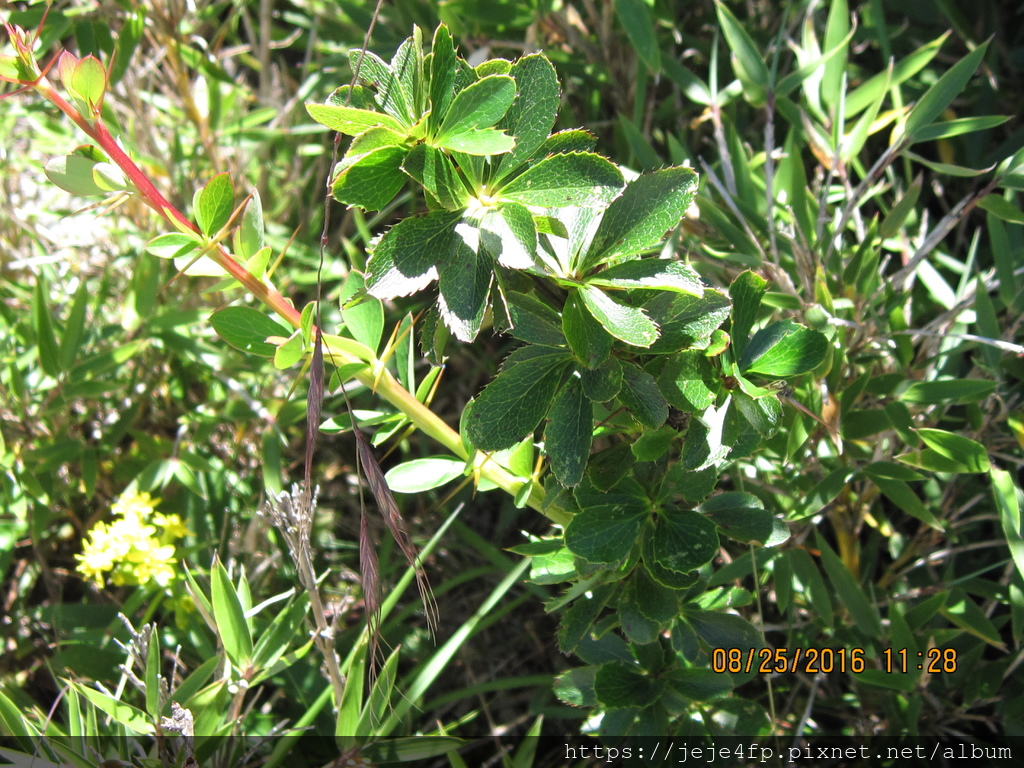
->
[494, 53, 559, 182]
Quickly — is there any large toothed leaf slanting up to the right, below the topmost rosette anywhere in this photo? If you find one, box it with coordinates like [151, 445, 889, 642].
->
[580, 168, 697, 269]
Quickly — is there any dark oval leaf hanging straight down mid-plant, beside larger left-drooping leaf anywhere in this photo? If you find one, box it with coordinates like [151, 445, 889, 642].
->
[544, 376, 594, 487]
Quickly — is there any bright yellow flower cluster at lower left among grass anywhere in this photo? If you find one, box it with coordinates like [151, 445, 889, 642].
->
[75, 492, 190, 587]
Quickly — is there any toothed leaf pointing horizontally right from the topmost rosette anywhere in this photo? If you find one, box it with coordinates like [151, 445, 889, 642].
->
[501, 153, 623, 208]
